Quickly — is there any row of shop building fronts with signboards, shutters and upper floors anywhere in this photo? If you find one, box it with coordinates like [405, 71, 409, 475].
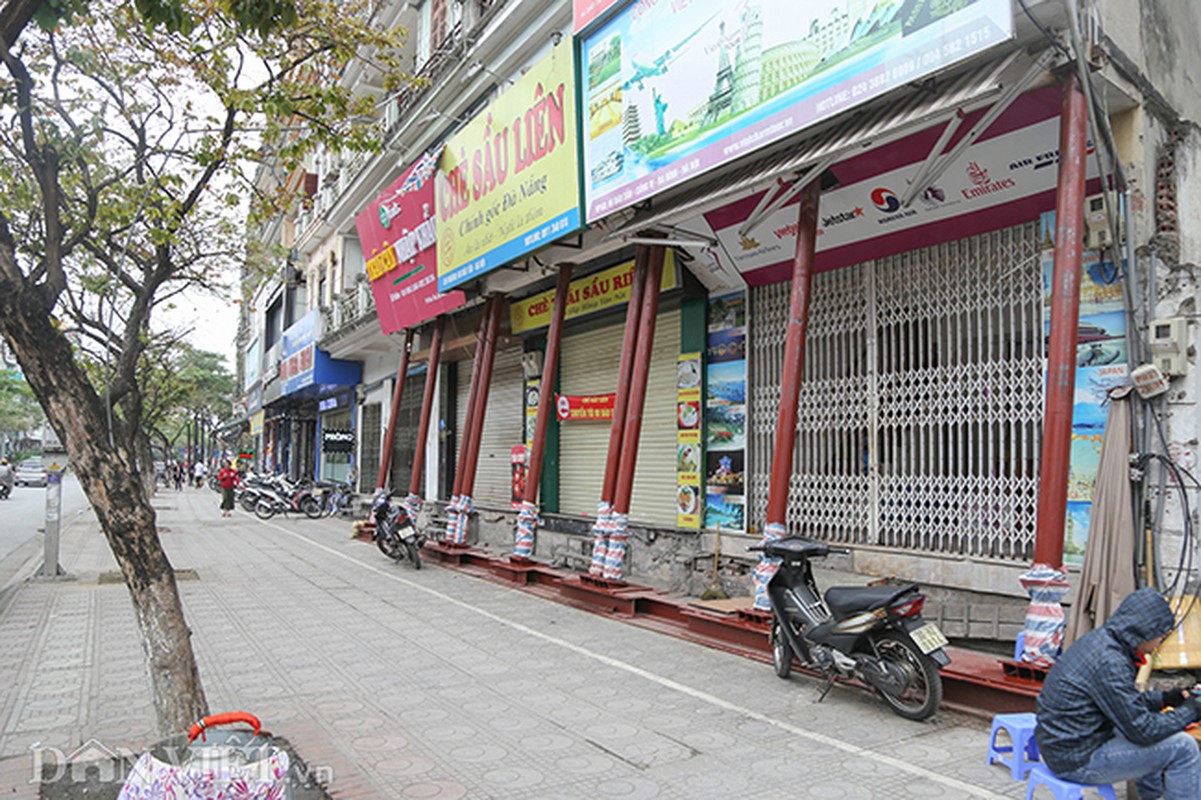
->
[241, 0, 1201, 634]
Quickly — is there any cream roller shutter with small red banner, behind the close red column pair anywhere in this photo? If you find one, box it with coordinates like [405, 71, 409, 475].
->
[558, 309, 680, 527]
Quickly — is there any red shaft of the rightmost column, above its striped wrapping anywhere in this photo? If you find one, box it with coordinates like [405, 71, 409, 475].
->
[1034, 73, 1088, 568]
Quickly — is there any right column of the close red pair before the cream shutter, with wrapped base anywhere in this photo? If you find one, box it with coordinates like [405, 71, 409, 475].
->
[604, 246, 667, 580]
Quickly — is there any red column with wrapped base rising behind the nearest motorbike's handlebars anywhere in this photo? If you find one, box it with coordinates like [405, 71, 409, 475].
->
[753, 180, 821, 610]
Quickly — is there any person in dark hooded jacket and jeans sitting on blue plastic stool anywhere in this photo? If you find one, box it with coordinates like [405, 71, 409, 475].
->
[1034, 589, 1201, 800]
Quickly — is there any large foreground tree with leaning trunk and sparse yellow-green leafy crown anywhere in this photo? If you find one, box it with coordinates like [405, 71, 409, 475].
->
[0, 0, 404, 733]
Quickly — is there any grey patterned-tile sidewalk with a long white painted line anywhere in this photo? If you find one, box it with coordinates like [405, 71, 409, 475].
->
[0, 489, 1066, 800]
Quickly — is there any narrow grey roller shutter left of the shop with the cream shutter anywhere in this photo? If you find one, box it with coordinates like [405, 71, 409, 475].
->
[455, 346, 525, 508]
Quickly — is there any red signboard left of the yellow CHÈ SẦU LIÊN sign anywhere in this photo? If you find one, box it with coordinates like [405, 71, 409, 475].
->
[354, 151, 464, 334]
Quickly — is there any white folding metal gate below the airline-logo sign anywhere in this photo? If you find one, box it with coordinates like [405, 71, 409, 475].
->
[748, 223, 1044, 560]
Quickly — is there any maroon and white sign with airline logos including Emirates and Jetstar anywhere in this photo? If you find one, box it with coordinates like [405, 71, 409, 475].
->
[704, 109, 1098, 286]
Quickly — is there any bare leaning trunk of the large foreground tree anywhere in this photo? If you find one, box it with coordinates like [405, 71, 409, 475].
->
[0, 287, 208, 735]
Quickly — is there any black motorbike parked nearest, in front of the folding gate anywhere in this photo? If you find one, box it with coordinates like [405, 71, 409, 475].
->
[748, 536, 951, 720]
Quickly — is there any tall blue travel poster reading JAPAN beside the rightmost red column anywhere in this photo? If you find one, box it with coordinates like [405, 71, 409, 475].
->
[1039, 211, 1130, 565]
